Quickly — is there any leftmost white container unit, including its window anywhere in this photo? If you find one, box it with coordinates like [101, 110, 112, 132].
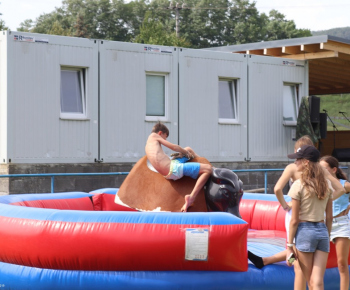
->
[0, 31, 98, 163]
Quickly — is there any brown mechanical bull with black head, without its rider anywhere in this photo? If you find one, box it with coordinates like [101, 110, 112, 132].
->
[115, 156, 243, 217]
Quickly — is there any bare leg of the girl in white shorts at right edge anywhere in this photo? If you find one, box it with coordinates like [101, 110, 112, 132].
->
[335, 238, 350, 290]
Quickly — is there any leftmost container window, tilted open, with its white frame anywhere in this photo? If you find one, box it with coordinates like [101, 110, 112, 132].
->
[61, 68, 86, 119]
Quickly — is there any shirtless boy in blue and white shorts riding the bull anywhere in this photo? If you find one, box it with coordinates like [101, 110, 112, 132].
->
[145, 122, 213, 212]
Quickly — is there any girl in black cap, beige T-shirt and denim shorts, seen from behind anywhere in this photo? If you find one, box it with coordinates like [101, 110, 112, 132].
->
[286, 145, 332, 290]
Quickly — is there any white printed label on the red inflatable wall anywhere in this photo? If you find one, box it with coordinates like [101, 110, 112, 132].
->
[185, 229, 209, 261]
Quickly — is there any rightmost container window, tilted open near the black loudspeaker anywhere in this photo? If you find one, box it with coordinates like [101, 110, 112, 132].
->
[283, 84, 299, 125]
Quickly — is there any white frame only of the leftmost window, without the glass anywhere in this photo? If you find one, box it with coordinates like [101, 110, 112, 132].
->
[60, 66, 88, 120]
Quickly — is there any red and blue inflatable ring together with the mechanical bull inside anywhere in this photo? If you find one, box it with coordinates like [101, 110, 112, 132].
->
[0, 159, 339, 290]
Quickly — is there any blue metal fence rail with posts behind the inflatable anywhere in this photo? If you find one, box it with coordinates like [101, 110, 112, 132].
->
[0, 166, 348, 193]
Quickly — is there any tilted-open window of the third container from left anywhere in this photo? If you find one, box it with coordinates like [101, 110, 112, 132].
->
[219, 79, 238, 123]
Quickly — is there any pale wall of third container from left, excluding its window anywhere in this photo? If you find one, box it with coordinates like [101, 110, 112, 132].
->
[179, 49, 247, 162]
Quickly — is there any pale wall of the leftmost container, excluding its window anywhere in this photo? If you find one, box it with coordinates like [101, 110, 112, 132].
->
[8, 32, 98, 163]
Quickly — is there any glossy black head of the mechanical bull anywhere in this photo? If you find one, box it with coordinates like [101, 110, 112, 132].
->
[205, 168, 243, 218]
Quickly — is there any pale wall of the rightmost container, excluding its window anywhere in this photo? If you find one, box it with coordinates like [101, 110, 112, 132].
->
[248, 56, 308, 161]
